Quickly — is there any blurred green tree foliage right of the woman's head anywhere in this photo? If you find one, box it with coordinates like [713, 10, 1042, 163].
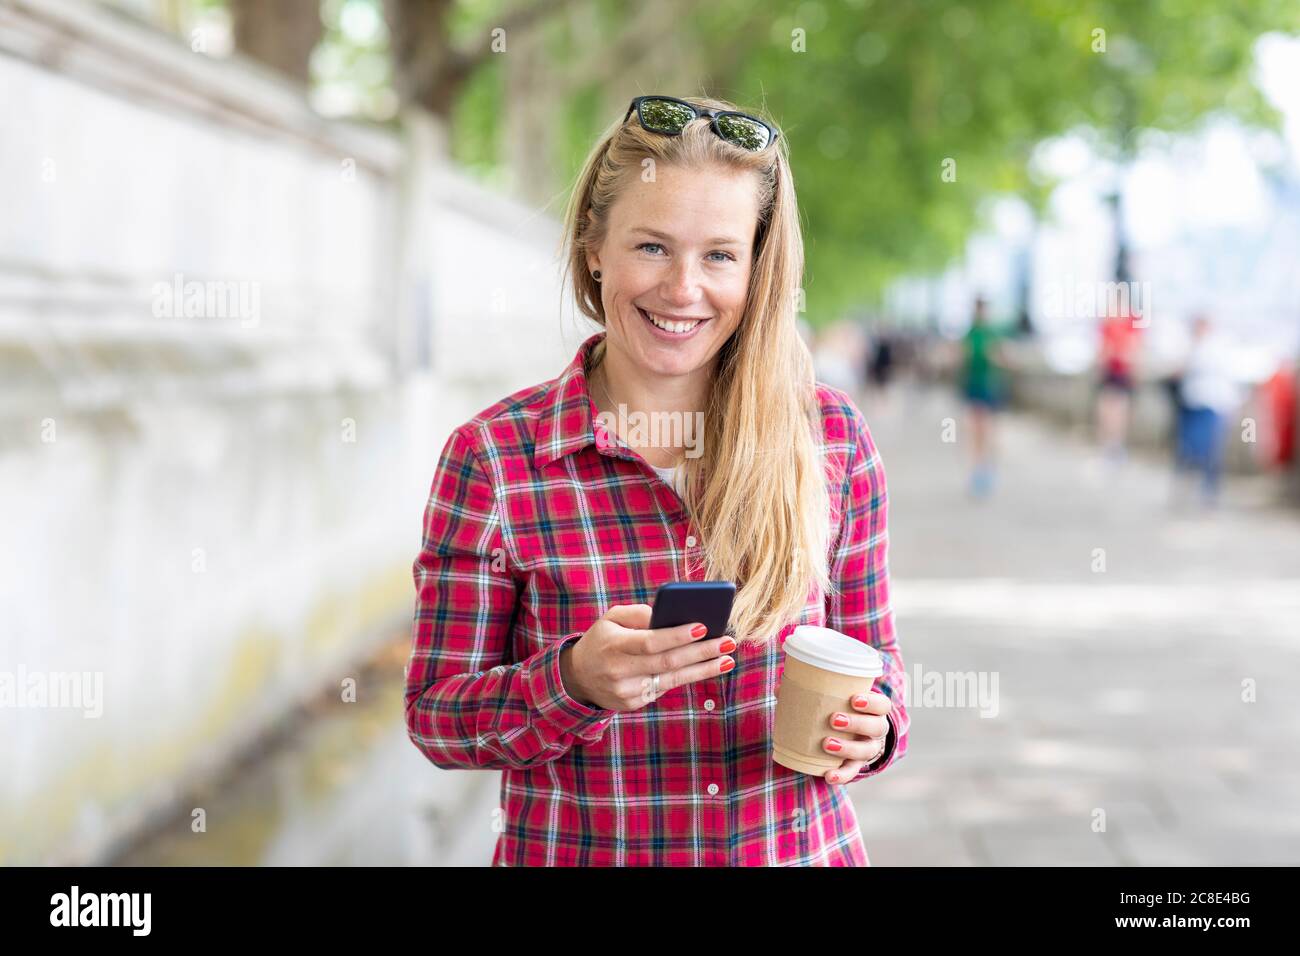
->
[733, 0, 1300, 323]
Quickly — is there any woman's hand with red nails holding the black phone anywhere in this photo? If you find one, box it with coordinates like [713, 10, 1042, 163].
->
[560, 604, 736, 710]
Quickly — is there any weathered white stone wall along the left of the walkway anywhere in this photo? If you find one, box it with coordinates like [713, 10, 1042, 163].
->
[0, 0, 580, 864]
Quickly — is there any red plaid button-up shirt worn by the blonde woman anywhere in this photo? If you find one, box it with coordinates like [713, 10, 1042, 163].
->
[406, 333, 909, 866]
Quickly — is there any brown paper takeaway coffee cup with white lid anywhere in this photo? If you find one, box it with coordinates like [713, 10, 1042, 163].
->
[772, 624, 883, 777]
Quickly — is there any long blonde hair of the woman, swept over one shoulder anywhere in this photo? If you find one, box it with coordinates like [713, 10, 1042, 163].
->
[563, 98, 831, 644]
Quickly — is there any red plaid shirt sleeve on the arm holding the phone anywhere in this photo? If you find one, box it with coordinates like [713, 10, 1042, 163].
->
[404, 427, 615, 769]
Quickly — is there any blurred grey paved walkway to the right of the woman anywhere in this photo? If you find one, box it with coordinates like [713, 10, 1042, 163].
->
[854, 382, 1300, 865]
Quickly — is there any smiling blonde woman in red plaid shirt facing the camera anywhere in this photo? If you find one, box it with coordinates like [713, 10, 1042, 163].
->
[406, 98, 907, 866]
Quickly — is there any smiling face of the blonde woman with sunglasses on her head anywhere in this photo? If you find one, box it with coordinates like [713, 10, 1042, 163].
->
[588, 165, 758, 378]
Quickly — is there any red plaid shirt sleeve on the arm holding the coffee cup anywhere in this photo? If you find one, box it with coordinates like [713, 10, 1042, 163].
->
[827, 397, 909, 783]
